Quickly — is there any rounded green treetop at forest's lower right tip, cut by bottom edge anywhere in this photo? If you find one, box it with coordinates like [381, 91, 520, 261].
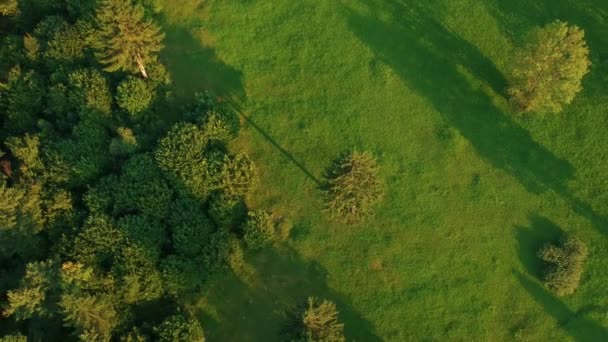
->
[154, 312, 205, 342]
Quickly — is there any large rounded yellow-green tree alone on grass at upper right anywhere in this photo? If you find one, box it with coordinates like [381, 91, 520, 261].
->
[508, 21, 591, 113]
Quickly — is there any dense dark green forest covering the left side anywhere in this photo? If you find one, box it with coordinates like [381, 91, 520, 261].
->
[0, 0, 288, 341]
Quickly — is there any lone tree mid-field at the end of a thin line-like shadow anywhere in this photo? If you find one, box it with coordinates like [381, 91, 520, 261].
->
[327, 152, 384, 223]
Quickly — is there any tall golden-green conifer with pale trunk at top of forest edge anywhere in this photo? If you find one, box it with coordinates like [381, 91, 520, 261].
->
[94, 0, 164, 78]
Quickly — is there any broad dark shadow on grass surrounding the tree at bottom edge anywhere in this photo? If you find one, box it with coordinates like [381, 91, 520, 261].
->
[196, 247, 380, 341]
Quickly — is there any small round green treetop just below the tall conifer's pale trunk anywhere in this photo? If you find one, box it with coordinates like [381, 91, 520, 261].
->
[116, 76, 154, 116]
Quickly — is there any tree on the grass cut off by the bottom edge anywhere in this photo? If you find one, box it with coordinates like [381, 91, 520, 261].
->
[284, 297, 346, 342]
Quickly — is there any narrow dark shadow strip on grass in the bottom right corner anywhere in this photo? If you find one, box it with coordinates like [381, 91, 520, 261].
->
[513, 271, 608, 342]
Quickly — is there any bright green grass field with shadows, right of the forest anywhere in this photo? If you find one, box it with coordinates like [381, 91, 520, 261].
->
[158, 0, 608, 341]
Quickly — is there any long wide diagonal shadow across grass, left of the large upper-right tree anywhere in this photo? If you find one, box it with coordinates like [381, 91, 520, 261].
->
[346, 1, 607, 233]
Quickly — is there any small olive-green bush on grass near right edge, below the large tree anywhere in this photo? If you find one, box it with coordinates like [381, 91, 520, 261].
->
[538, 237, 588, 296]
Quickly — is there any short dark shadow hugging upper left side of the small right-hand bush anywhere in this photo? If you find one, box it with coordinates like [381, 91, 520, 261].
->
[515, 215, 564, 279]
